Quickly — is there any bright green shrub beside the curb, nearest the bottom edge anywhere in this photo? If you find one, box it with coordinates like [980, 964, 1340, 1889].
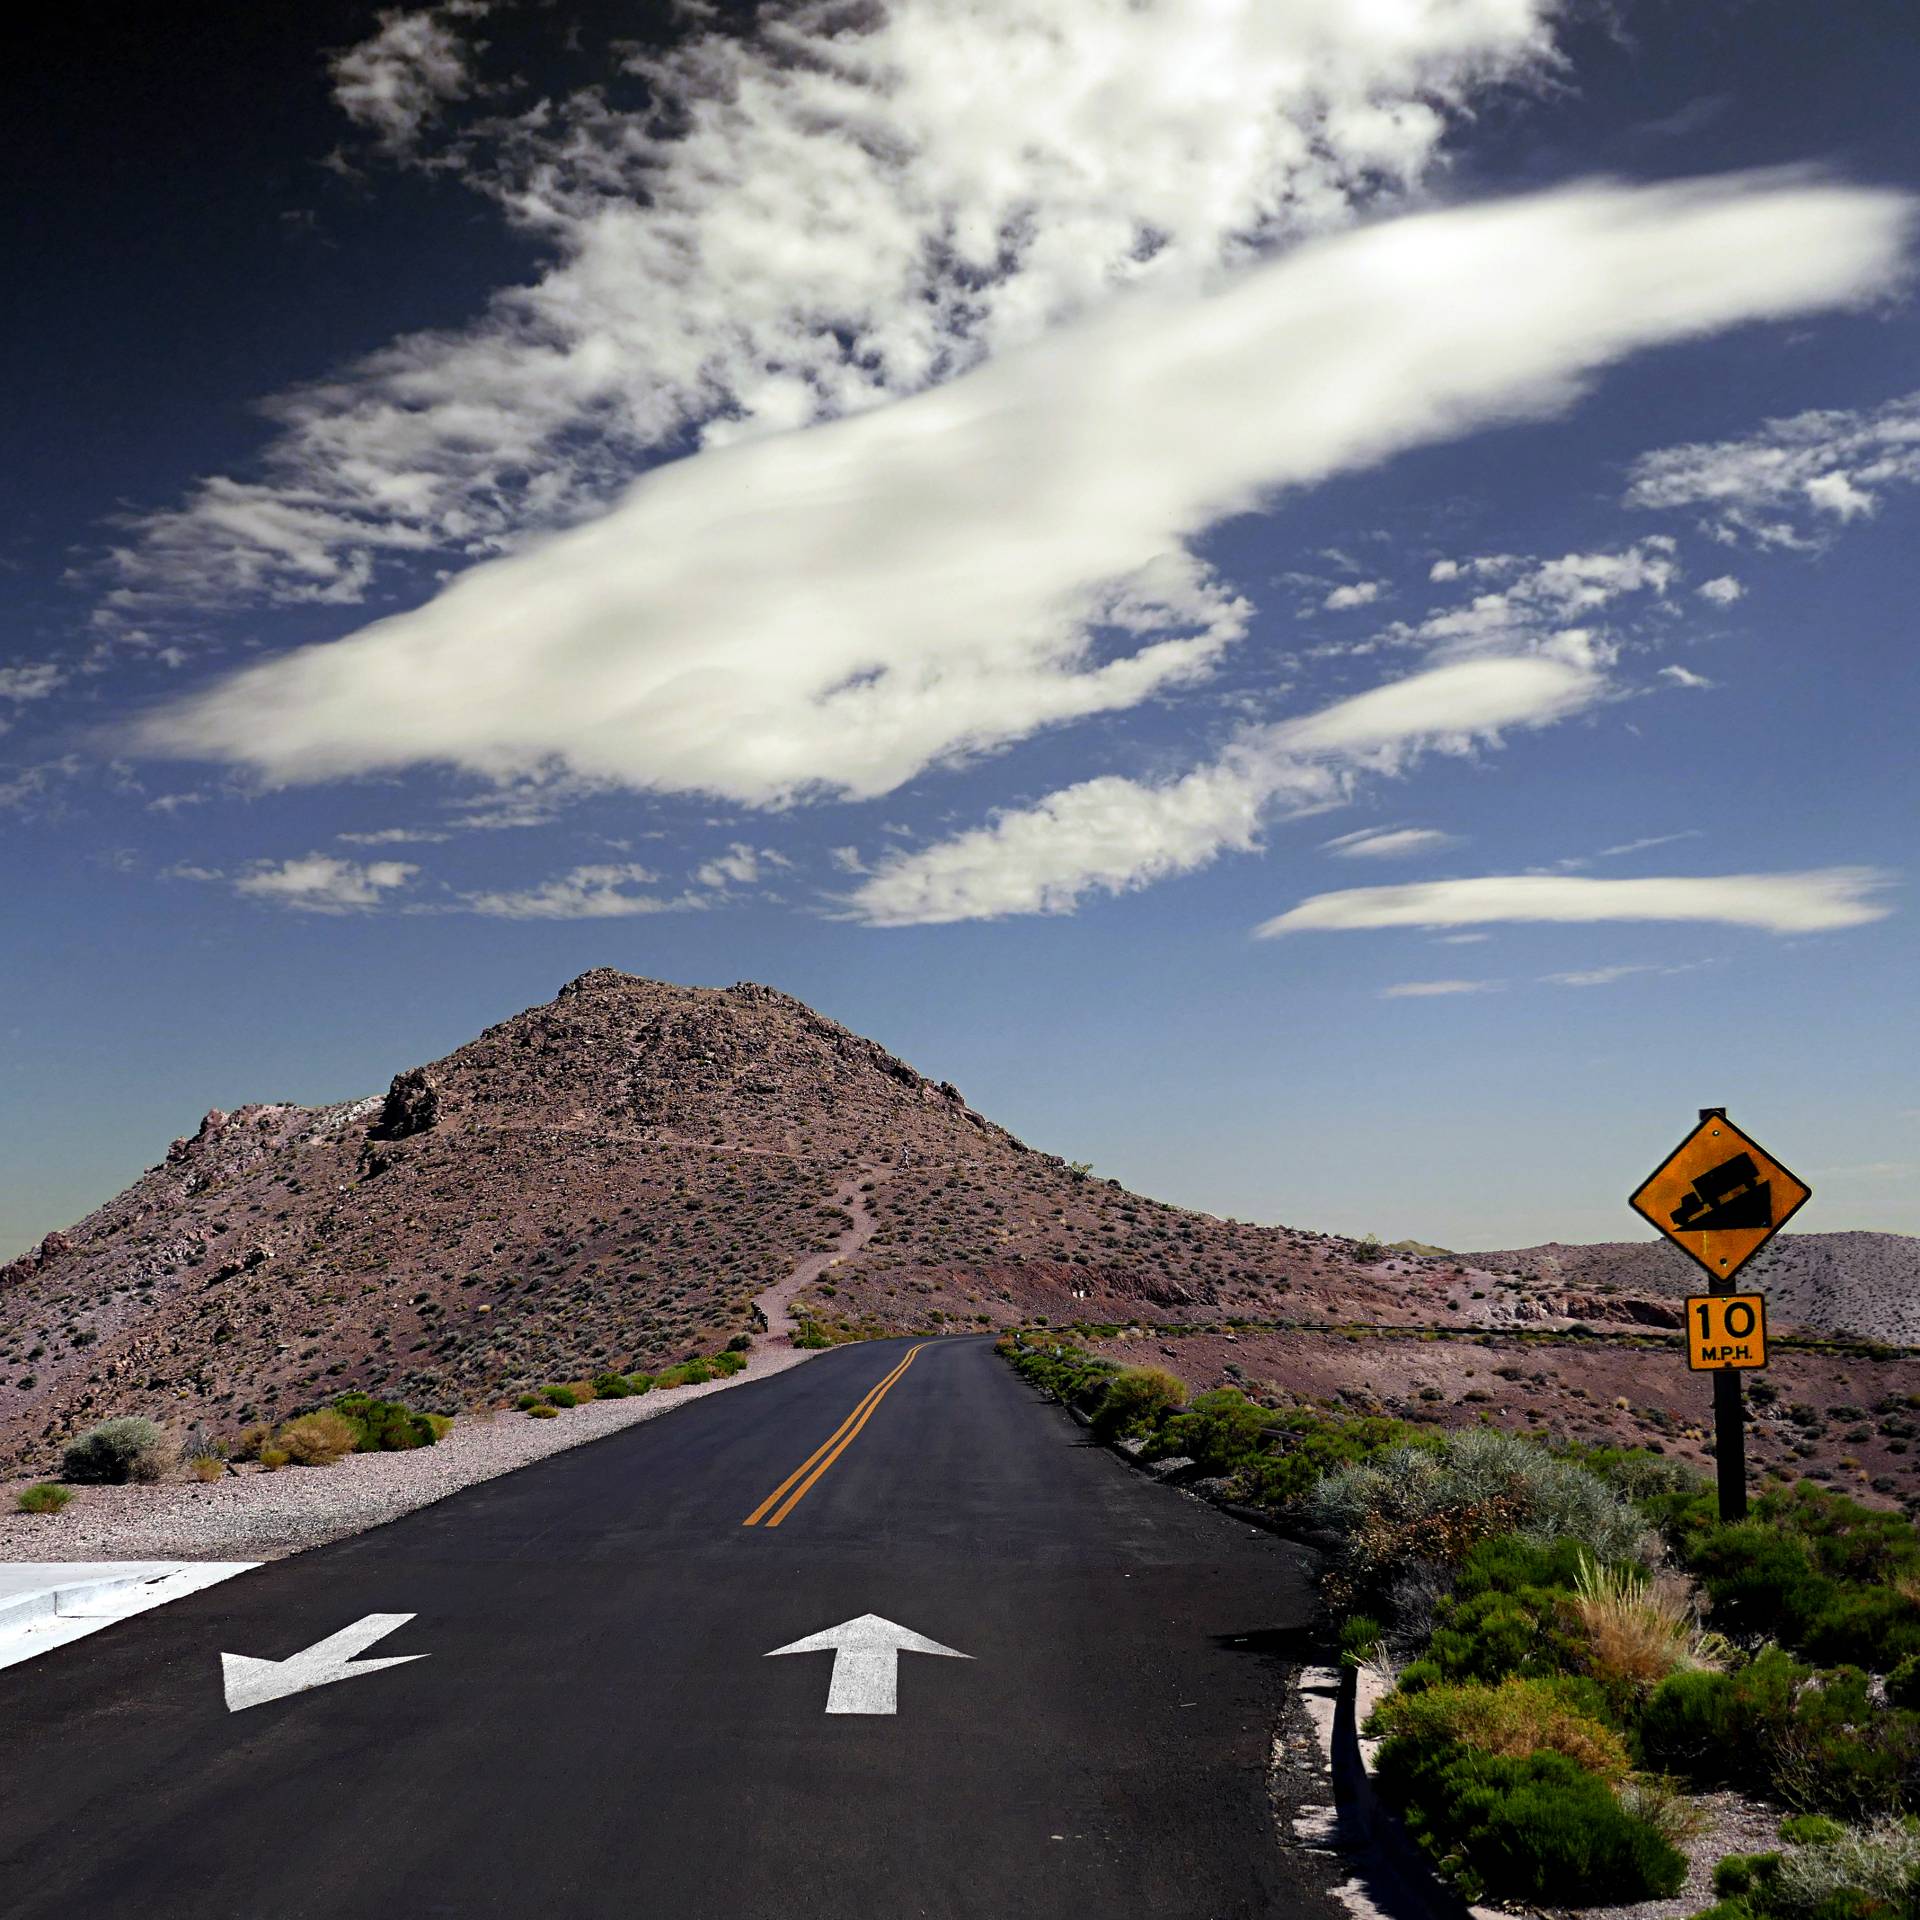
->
[1379, 1738, 1686, 1905]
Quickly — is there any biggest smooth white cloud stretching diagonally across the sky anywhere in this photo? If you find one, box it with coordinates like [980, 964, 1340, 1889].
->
[140, 175, 1908, 804]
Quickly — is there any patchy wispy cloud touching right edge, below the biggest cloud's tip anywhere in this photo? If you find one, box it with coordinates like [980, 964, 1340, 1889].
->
[1626, 394, 1920, 549]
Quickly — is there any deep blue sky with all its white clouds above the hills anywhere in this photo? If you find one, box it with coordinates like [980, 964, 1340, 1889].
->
[0, 0, 1920, 1254]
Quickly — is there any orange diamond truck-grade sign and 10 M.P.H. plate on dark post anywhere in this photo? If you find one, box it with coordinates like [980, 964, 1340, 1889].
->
[1628, 1106, 1812, 1521]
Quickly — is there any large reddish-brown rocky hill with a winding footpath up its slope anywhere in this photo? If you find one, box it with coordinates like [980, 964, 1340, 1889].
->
[0, 968, 1914, 1475]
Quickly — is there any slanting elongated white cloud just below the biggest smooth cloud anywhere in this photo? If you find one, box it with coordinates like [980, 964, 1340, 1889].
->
[851, 659, 1605, 925]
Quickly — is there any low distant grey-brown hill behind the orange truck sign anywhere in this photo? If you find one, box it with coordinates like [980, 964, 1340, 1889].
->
[1465, 1233, 1920, 1346]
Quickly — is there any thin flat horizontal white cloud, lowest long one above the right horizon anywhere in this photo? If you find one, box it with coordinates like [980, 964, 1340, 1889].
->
[1254, 866, 1893, 939]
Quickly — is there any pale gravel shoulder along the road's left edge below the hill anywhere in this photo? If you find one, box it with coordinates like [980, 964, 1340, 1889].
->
[0, 1342, 816, 1561]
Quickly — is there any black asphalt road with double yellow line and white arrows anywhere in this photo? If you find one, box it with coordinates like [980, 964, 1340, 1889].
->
[0, 1340, 1327, 1920]
